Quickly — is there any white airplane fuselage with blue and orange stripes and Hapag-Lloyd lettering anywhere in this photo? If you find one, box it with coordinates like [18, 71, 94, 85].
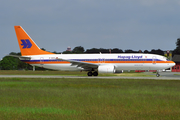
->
[22, 53, 175, 71]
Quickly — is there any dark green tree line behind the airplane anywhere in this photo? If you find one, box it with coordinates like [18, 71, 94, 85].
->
[0, 38, 180, 70]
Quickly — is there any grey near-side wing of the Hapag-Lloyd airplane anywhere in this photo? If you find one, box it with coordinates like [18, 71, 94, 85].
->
[58, 58, 99, 70]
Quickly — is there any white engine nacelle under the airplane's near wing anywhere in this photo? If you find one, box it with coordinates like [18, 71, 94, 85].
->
[98, 65, 115, 73]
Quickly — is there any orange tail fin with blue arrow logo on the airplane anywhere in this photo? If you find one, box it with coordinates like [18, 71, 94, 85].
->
[14, 26, 53, 56]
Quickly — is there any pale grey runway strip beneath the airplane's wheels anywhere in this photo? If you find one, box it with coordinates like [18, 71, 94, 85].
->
[0, 72, 180, 80]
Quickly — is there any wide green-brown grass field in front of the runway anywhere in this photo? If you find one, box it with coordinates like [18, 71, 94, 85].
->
[0, 78, 180, 120]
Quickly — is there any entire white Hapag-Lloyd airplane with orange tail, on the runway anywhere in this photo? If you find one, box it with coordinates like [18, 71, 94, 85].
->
[14, 26, 175, 77]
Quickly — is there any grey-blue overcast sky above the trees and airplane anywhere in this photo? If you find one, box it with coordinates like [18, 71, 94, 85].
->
[0, 0, 180, 59]
